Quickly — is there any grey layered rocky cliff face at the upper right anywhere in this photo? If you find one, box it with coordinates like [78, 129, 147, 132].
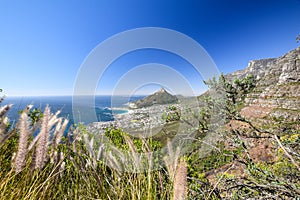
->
[226, 47, 300, 118]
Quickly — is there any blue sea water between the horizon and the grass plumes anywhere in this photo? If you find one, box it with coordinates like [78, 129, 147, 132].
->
[0, 96, 144, 125]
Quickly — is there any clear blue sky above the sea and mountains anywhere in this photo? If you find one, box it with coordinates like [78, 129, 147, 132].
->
[0, 0, 300, 96]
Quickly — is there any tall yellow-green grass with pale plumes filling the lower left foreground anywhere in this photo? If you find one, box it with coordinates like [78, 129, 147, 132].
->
[0, 106, 186, 200]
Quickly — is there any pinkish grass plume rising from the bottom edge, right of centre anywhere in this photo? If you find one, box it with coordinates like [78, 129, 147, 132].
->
[173, 158, 187, 200]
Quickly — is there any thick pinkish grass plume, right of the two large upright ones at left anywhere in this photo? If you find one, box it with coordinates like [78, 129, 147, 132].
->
[34, 105, 51, 169]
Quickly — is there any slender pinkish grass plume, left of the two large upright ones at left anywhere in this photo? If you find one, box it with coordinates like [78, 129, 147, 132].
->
[14, 105, 32, 172]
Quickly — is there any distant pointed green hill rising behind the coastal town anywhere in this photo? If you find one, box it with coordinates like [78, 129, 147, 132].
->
[130, 88, 178, 108]
